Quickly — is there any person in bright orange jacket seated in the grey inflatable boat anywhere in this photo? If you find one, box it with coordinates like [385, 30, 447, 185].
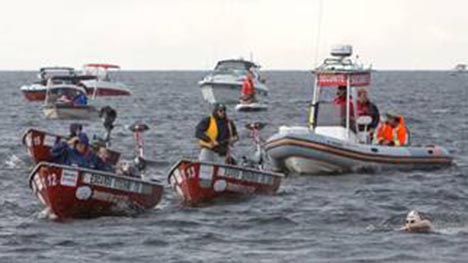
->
[376, 111, 408, 146]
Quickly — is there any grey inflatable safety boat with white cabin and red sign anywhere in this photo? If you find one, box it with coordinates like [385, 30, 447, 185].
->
[265, 46, 453, 174]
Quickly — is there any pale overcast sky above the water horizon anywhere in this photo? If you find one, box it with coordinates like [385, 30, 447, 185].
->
[0, 0, 468, 70]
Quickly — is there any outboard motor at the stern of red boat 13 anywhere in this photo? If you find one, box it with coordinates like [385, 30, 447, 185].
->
[241, 122, 266, 170]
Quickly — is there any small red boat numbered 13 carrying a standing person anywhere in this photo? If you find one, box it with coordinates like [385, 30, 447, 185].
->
[168, 160, 283, 205]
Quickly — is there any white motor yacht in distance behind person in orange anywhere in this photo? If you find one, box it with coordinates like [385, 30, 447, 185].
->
[198, 59, 268, 103]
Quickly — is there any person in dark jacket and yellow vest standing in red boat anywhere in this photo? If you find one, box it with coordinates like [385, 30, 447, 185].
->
[195, 104, 239, 164]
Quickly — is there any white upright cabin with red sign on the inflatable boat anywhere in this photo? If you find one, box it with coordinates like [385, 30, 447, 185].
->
[309, 46, 371, 143]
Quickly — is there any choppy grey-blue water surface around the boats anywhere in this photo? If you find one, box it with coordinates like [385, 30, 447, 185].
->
[0, 72, 468, 262]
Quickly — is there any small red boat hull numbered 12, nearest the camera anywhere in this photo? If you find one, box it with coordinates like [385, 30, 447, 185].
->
[29, 162, 163, 219]
